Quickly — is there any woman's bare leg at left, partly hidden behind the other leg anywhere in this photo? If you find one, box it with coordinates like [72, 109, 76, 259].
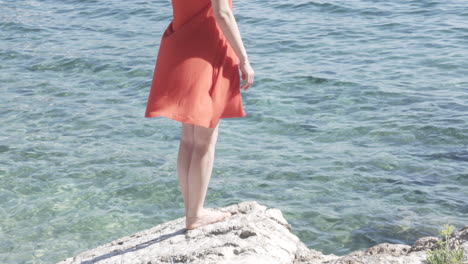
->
[177, 123, 194, 215]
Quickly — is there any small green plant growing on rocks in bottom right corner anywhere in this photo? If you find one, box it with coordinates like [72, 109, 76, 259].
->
[425, 224, 465, 264]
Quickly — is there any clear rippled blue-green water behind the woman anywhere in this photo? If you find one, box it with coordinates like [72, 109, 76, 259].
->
[0, 0, 468, 263]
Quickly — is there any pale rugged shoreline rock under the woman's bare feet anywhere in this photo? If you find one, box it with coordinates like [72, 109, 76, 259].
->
[58, 201, 468, 264]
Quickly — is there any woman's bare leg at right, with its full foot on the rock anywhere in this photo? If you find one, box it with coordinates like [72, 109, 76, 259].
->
[186, 122, 231, 229]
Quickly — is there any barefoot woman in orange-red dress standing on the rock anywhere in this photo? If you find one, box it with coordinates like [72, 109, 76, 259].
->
[145, 0, 254, 229]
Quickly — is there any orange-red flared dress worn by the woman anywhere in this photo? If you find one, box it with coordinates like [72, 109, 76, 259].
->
[145, 0, 246, 128]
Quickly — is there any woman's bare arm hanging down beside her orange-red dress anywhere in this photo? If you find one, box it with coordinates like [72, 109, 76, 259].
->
[211, 0, 255, 90]
